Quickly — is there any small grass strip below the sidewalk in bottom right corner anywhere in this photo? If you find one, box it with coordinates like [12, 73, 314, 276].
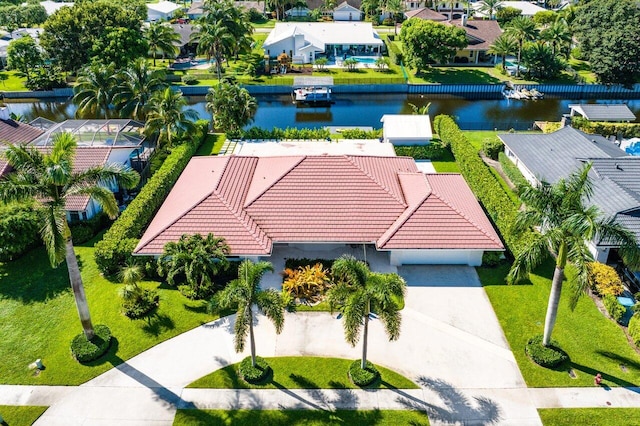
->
[538, 408, 640, 426]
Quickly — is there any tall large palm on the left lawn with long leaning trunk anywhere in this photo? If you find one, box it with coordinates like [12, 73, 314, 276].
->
[0, 132, 139, 339]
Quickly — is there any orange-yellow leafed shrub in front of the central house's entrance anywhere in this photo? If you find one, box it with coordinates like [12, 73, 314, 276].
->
[282, 263, 331, 302]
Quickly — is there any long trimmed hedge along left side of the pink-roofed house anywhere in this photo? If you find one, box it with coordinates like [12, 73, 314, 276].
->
[95, 120, 208, 275]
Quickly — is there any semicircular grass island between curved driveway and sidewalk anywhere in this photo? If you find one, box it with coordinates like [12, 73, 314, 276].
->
[188, 357, 418, 389]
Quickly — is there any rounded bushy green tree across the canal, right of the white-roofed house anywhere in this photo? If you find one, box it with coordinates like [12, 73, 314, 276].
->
[400, 18, 468, 71]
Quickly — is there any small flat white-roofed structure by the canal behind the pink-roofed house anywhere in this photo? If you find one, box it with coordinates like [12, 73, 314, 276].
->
[380, 114, 433, 145]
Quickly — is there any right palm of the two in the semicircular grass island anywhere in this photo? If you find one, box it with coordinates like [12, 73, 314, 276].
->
[327, 255, 406, 370]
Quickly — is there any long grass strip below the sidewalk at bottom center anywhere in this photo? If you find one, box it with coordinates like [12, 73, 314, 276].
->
[173, 410, 429, 426]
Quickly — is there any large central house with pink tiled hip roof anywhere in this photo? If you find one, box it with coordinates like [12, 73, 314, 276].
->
[134, 155, 504, 265]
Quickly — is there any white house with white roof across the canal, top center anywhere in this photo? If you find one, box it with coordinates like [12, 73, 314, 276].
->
[262, 22, 384, 64]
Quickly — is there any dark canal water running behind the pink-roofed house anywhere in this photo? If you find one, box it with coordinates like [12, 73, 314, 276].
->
[8, 94, 640, 130]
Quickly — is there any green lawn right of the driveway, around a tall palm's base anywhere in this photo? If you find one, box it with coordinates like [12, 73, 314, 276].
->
[478, 262, 640, 387]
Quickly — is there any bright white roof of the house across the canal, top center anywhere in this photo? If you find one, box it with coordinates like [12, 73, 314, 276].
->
[263, 22, 383, 50]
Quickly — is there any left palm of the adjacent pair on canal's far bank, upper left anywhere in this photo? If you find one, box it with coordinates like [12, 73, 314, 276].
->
[73, 64, 116, 119]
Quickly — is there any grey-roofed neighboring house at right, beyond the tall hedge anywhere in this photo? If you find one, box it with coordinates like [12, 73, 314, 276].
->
[498, 127, 640, 262]
